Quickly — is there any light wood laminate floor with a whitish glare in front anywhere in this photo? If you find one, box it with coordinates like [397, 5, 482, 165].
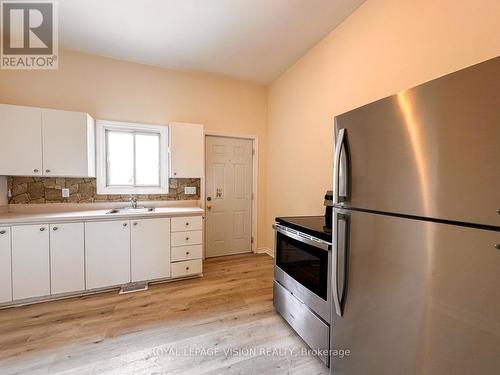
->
[0, 254, 328, 375]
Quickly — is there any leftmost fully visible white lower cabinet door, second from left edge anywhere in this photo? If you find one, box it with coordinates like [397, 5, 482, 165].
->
[11, 225, 50, 300]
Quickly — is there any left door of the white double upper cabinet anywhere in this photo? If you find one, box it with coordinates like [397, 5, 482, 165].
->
[0, 104, 42, 176]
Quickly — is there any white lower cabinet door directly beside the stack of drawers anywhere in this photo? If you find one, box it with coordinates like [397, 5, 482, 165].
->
[131, 218, 170, 281]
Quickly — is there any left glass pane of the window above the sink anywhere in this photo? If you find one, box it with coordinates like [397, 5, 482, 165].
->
[106, 131, 134, 186]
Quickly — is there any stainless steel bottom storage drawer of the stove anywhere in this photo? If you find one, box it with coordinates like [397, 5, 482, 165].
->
[273, 281, 330, 365]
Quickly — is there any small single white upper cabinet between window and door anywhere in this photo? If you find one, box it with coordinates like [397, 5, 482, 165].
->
[169, 122, 204, 178]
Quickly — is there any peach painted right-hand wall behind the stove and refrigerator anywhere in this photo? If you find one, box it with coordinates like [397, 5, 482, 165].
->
[266, 0, 500, 247]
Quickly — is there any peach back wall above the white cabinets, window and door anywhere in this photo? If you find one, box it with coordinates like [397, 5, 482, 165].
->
[0, 51, 267, 247]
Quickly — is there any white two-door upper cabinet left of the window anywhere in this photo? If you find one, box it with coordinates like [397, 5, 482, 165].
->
[0, 104, 95, 177]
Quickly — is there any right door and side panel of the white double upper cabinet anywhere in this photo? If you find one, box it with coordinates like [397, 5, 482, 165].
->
[42, 109, 95, 177]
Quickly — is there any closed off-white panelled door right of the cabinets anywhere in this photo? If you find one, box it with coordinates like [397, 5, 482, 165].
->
[205, 136, 253, 257]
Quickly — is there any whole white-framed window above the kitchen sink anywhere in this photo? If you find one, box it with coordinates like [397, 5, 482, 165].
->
[97, 121, 168, 194]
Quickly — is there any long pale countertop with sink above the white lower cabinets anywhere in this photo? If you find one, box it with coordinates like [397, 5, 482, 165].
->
[0, 207, 204, 226]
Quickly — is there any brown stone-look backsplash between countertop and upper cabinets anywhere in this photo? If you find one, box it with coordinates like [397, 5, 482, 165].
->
[7, 177, 201, 204]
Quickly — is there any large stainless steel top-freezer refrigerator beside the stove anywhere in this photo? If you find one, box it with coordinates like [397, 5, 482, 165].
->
[330, 57, 500, 375]
